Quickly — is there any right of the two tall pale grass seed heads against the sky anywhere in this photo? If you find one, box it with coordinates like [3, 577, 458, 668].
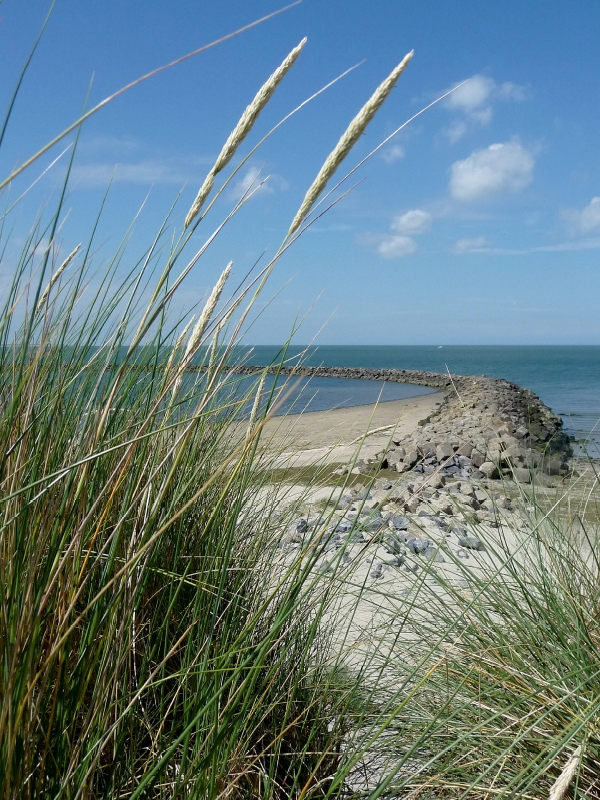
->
[287, 50, 414, 236]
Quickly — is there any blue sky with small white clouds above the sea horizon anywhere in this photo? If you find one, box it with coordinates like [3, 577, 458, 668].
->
[0, 0, 600, 345]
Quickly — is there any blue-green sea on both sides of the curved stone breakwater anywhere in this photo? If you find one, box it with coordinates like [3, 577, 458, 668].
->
[237, 345, 600, 458]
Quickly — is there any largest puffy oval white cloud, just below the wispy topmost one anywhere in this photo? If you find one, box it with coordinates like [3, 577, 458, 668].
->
[450, 141, 535, 201]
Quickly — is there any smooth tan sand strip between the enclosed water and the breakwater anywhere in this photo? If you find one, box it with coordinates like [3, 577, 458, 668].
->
[264, 392, 444, 467]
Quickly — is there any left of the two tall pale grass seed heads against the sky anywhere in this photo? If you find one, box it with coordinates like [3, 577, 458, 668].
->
[185, 37, 306, 228]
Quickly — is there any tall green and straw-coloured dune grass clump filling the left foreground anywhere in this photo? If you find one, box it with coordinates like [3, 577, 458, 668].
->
[0, 17, 418, 799]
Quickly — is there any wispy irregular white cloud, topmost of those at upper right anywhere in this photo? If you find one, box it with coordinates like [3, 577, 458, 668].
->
[443, 75, 526, 144]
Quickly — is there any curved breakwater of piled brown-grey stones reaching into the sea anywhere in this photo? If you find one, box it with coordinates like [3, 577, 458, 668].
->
[229, 366, 573, 483]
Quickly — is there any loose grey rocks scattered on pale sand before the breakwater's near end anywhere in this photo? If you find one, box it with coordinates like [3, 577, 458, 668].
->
[280, 473, 521, 580]
